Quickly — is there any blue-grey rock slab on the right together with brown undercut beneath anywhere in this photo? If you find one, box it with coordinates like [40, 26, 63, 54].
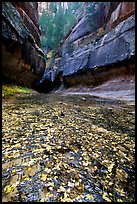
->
[60, 16, 135, 85]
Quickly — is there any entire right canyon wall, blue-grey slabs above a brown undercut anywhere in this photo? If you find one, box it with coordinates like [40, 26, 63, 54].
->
[38, 2, 135, 90]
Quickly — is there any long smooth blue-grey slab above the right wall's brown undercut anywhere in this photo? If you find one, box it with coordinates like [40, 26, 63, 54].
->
[60, 16, 135, 79]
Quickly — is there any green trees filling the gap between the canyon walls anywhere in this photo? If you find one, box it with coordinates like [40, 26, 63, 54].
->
[39, 2, 82, 51]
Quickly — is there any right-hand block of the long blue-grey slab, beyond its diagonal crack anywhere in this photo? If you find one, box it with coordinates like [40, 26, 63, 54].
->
[89, 17, 135, 69]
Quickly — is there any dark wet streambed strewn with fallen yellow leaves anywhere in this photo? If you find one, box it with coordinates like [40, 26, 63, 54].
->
[2, 93, 135, 202]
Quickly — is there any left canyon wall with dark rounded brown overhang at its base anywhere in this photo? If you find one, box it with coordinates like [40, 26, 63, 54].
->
[2, 2, 45, 87]
